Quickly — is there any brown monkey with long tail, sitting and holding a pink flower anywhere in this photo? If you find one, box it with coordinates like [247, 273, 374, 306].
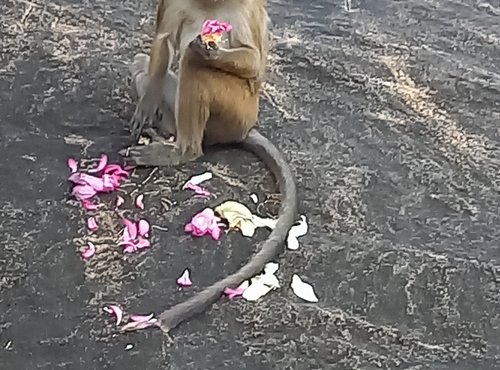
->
[120, 0, 298, 332]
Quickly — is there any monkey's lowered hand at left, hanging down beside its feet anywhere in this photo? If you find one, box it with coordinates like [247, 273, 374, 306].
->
[130, 83, 165, 140]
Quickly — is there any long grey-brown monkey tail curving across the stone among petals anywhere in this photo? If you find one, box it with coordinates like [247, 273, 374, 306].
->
[147, 128, 298, 332]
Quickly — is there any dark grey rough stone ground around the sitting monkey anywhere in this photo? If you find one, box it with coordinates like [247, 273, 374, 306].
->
[0, 0, 500, 370]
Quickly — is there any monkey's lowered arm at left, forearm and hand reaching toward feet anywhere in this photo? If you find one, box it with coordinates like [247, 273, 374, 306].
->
[130, 34, 173, 139]
